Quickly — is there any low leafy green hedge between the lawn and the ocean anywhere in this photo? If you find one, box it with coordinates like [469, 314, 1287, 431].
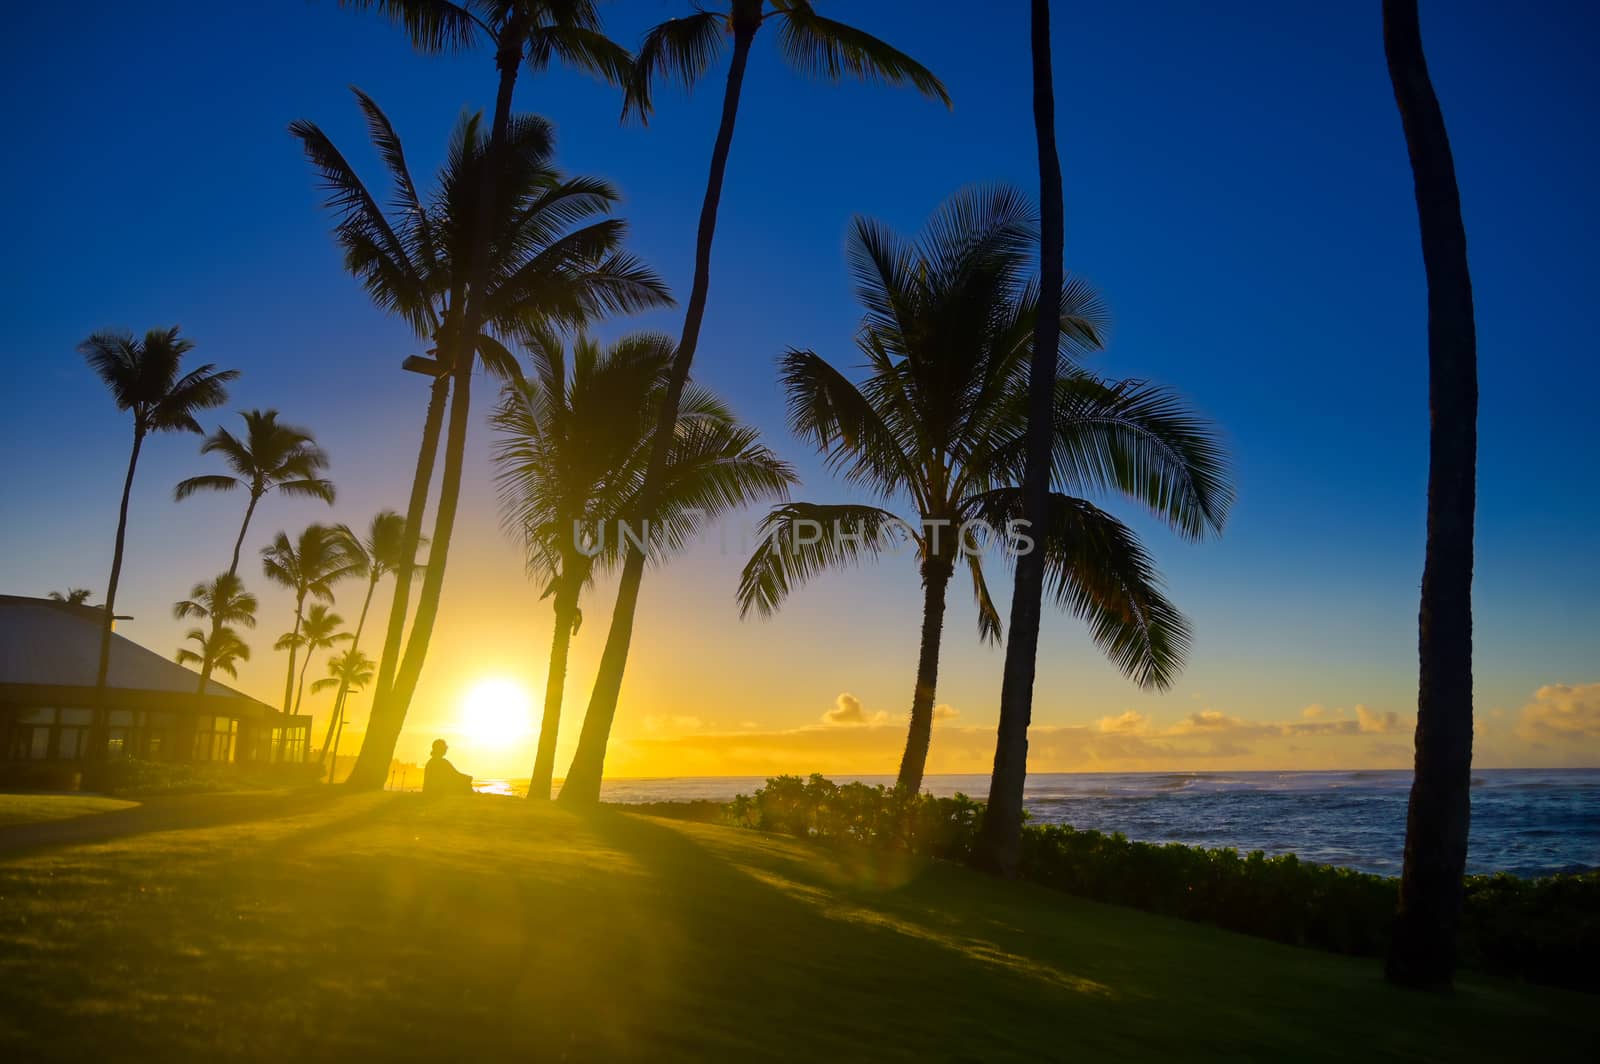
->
[716, 774, 1600, 990]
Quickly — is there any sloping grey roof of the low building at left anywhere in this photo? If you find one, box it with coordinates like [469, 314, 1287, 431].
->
[0, 595, 277, 717]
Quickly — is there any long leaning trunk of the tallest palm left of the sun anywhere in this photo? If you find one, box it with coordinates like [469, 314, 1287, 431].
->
[350, 31, 523, 789]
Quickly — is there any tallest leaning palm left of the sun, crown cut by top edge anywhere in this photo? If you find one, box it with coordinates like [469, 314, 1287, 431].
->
[331, 0, 636, 787]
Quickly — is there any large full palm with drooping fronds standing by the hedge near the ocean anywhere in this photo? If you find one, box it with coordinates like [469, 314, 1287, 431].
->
[738, 187, 1230, 792]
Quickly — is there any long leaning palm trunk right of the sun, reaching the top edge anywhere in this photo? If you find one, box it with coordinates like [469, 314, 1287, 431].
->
[560, 19, 760, 803]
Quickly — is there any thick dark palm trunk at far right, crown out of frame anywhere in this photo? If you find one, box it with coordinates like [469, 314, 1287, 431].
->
[1384, 0, 1478, 989]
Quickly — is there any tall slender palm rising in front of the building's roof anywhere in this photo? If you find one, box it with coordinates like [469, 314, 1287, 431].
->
[78, 325, 238, 704]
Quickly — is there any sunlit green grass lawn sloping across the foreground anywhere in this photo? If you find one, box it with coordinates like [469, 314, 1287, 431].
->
[0, 794, 1600, 1061]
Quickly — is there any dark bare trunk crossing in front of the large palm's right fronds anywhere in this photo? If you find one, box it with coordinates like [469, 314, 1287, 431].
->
[973, 0, 1066, 877]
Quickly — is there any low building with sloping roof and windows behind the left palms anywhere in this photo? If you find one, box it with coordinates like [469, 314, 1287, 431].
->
[0, 595, 310, 776]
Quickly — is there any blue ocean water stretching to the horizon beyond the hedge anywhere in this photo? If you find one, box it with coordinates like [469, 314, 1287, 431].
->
[475, 768, 1600, 875]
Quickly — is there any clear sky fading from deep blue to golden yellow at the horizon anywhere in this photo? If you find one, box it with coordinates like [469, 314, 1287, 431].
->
[0, 0, 1600, 768]
